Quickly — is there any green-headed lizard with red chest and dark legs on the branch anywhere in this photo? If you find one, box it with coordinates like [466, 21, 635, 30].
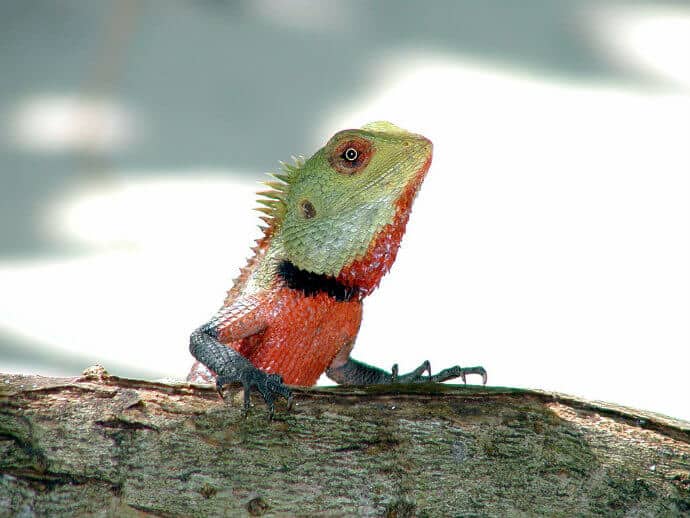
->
[187, 121, 487, 419]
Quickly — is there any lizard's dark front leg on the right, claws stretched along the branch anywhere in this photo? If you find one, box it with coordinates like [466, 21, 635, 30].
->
[326, 344, 487, 385]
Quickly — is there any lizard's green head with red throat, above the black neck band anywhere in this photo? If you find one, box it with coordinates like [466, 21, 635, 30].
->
[263, 122, 432, 294]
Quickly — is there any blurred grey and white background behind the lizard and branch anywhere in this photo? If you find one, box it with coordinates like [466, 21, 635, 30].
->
[0, 0, 690, 419]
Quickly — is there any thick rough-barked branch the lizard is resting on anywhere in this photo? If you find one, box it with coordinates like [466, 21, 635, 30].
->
[0, 368, 690, 517]
